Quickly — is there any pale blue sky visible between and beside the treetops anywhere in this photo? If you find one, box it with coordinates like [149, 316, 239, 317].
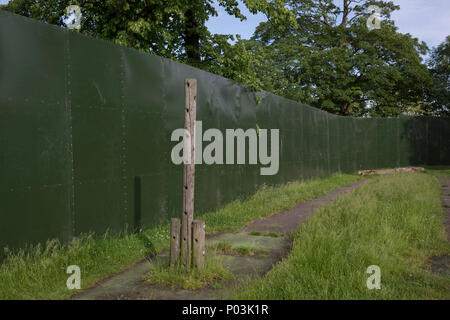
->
[0, 0, 450, 48]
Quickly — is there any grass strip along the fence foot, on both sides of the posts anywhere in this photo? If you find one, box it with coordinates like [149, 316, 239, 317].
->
[0, 174, 359, 299]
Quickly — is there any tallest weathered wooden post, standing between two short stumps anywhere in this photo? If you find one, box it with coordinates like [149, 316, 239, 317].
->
[181, 79, 197, 269]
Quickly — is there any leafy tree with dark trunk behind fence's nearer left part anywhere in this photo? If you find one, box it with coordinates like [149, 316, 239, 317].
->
[5, 0, 293, 68]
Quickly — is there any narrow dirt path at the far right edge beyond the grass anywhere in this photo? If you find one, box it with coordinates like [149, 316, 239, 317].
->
[431, 178, 450, 277]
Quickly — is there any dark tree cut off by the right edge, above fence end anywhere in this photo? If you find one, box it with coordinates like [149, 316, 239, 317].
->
[428, 36, 450, 116]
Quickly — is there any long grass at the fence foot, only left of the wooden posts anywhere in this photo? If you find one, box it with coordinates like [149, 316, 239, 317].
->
[0, 227, 169, 300]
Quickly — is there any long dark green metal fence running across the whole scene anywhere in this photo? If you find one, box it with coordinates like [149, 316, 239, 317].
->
[0, 11, 450, 247]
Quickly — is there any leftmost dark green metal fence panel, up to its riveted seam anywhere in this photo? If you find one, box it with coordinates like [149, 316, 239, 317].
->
[0, 12, 73, 248]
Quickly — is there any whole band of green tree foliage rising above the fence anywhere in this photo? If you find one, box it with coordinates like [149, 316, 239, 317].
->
[1, 0, 449, 116]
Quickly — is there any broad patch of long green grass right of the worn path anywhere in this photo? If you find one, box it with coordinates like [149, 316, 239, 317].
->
[233, 173, 450, 299]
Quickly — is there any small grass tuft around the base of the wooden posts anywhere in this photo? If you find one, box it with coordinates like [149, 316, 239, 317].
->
[144, 253, 234, 290]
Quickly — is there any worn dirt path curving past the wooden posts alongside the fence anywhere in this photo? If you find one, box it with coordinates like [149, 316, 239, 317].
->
[72, 179, 367, 300]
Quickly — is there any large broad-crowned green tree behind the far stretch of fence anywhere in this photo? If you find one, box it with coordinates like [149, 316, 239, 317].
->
[246, 0, 431, 116]
